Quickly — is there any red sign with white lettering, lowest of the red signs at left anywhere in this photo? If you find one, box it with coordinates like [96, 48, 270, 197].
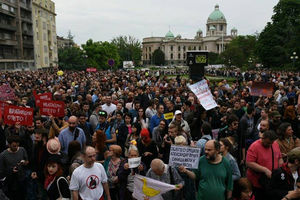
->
[4, 105, 33, 126]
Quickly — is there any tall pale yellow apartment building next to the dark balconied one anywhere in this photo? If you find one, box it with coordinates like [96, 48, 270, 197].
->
[32, 0, 58, 69]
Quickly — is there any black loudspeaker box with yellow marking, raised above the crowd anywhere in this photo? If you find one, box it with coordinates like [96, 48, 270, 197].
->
[186, 51, 208, 81]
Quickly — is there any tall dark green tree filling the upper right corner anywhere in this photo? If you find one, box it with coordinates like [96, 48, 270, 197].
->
[256, 0, 300, 69]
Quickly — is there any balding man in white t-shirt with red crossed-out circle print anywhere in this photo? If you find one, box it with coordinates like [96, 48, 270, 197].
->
[69, 146, 111, 200]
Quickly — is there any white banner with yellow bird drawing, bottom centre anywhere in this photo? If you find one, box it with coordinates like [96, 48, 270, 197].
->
[132, 174, 176, 200]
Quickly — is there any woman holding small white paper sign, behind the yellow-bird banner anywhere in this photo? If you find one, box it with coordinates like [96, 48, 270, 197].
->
[117, 145, 146, 200]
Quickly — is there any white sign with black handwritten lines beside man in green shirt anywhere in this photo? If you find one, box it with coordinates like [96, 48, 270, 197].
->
[169, 145, 201, 169]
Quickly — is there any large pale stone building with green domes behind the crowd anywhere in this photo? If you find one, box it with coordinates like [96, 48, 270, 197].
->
[142, 5, 237, 65]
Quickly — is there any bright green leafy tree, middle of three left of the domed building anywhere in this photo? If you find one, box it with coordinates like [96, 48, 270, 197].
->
[81, 39, 120, 69]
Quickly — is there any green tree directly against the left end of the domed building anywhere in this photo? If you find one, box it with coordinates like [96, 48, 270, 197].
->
[111, 36, 142, 67]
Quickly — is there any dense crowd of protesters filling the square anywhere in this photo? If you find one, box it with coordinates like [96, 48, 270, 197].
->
[0, 70, 300, 200]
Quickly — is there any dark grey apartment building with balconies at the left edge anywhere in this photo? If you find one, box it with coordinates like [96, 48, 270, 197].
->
[0, 0, 34, 70]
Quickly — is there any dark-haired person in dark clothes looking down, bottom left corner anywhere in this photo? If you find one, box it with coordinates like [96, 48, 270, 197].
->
[0, 136, 28, 200]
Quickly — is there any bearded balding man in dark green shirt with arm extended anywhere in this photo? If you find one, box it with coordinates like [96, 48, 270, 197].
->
[179, 140, 233, 200]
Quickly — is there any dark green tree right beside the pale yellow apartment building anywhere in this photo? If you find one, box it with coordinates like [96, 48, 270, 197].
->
[58, 47, 85, 70]
